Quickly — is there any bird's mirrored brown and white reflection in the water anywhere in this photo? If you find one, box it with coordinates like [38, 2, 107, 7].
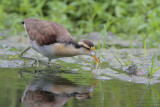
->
[22, 75, 96, 107]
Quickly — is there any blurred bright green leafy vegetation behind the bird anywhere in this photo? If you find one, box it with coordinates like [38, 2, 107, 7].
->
[0, 0, 160, 48]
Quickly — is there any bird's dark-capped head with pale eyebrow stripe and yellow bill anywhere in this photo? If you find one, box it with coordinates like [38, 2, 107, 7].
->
[78, 40, 100, 64]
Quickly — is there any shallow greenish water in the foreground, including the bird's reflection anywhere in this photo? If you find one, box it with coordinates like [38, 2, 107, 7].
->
[0, 68, 160, 107]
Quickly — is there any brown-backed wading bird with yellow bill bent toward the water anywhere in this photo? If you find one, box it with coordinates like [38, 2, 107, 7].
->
[20, 18, 100, 64]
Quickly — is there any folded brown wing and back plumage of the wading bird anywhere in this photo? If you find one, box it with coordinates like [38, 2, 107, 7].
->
[24, 19, 73, 46]
